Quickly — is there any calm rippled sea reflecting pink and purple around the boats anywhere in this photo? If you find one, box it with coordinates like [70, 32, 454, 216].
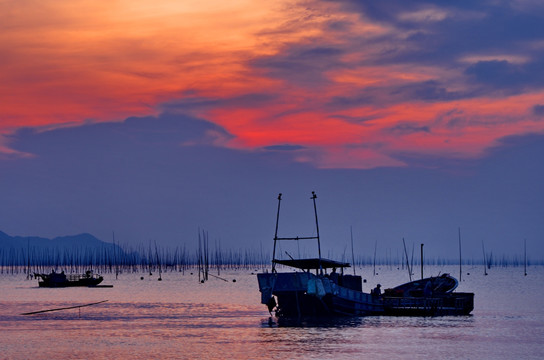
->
[0, 267, 544, 360]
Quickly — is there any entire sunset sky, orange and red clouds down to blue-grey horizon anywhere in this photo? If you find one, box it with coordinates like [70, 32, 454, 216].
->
[0, 0, 544, 258]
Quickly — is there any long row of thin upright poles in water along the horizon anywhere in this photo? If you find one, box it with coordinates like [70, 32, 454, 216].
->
[0, 235, 544, 274]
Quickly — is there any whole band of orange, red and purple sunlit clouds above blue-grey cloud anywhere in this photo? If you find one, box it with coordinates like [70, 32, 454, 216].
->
[0, 0, 544, 168]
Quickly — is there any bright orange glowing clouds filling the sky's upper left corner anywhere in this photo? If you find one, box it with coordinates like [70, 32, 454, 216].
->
[0, 1, 286, 126]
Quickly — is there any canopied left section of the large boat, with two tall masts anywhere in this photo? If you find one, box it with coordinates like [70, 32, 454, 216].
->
[257, 192, 384, 319]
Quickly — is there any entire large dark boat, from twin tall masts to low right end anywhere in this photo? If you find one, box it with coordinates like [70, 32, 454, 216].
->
[257, 192, 474, 319]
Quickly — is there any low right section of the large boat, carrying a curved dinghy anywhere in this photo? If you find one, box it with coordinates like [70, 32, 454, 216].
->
[383, 274, 474, 316]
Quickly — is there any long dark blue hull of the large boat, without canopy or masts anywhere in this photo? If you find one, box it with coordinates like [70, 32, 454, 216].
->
[257, 272, 474, 318]
